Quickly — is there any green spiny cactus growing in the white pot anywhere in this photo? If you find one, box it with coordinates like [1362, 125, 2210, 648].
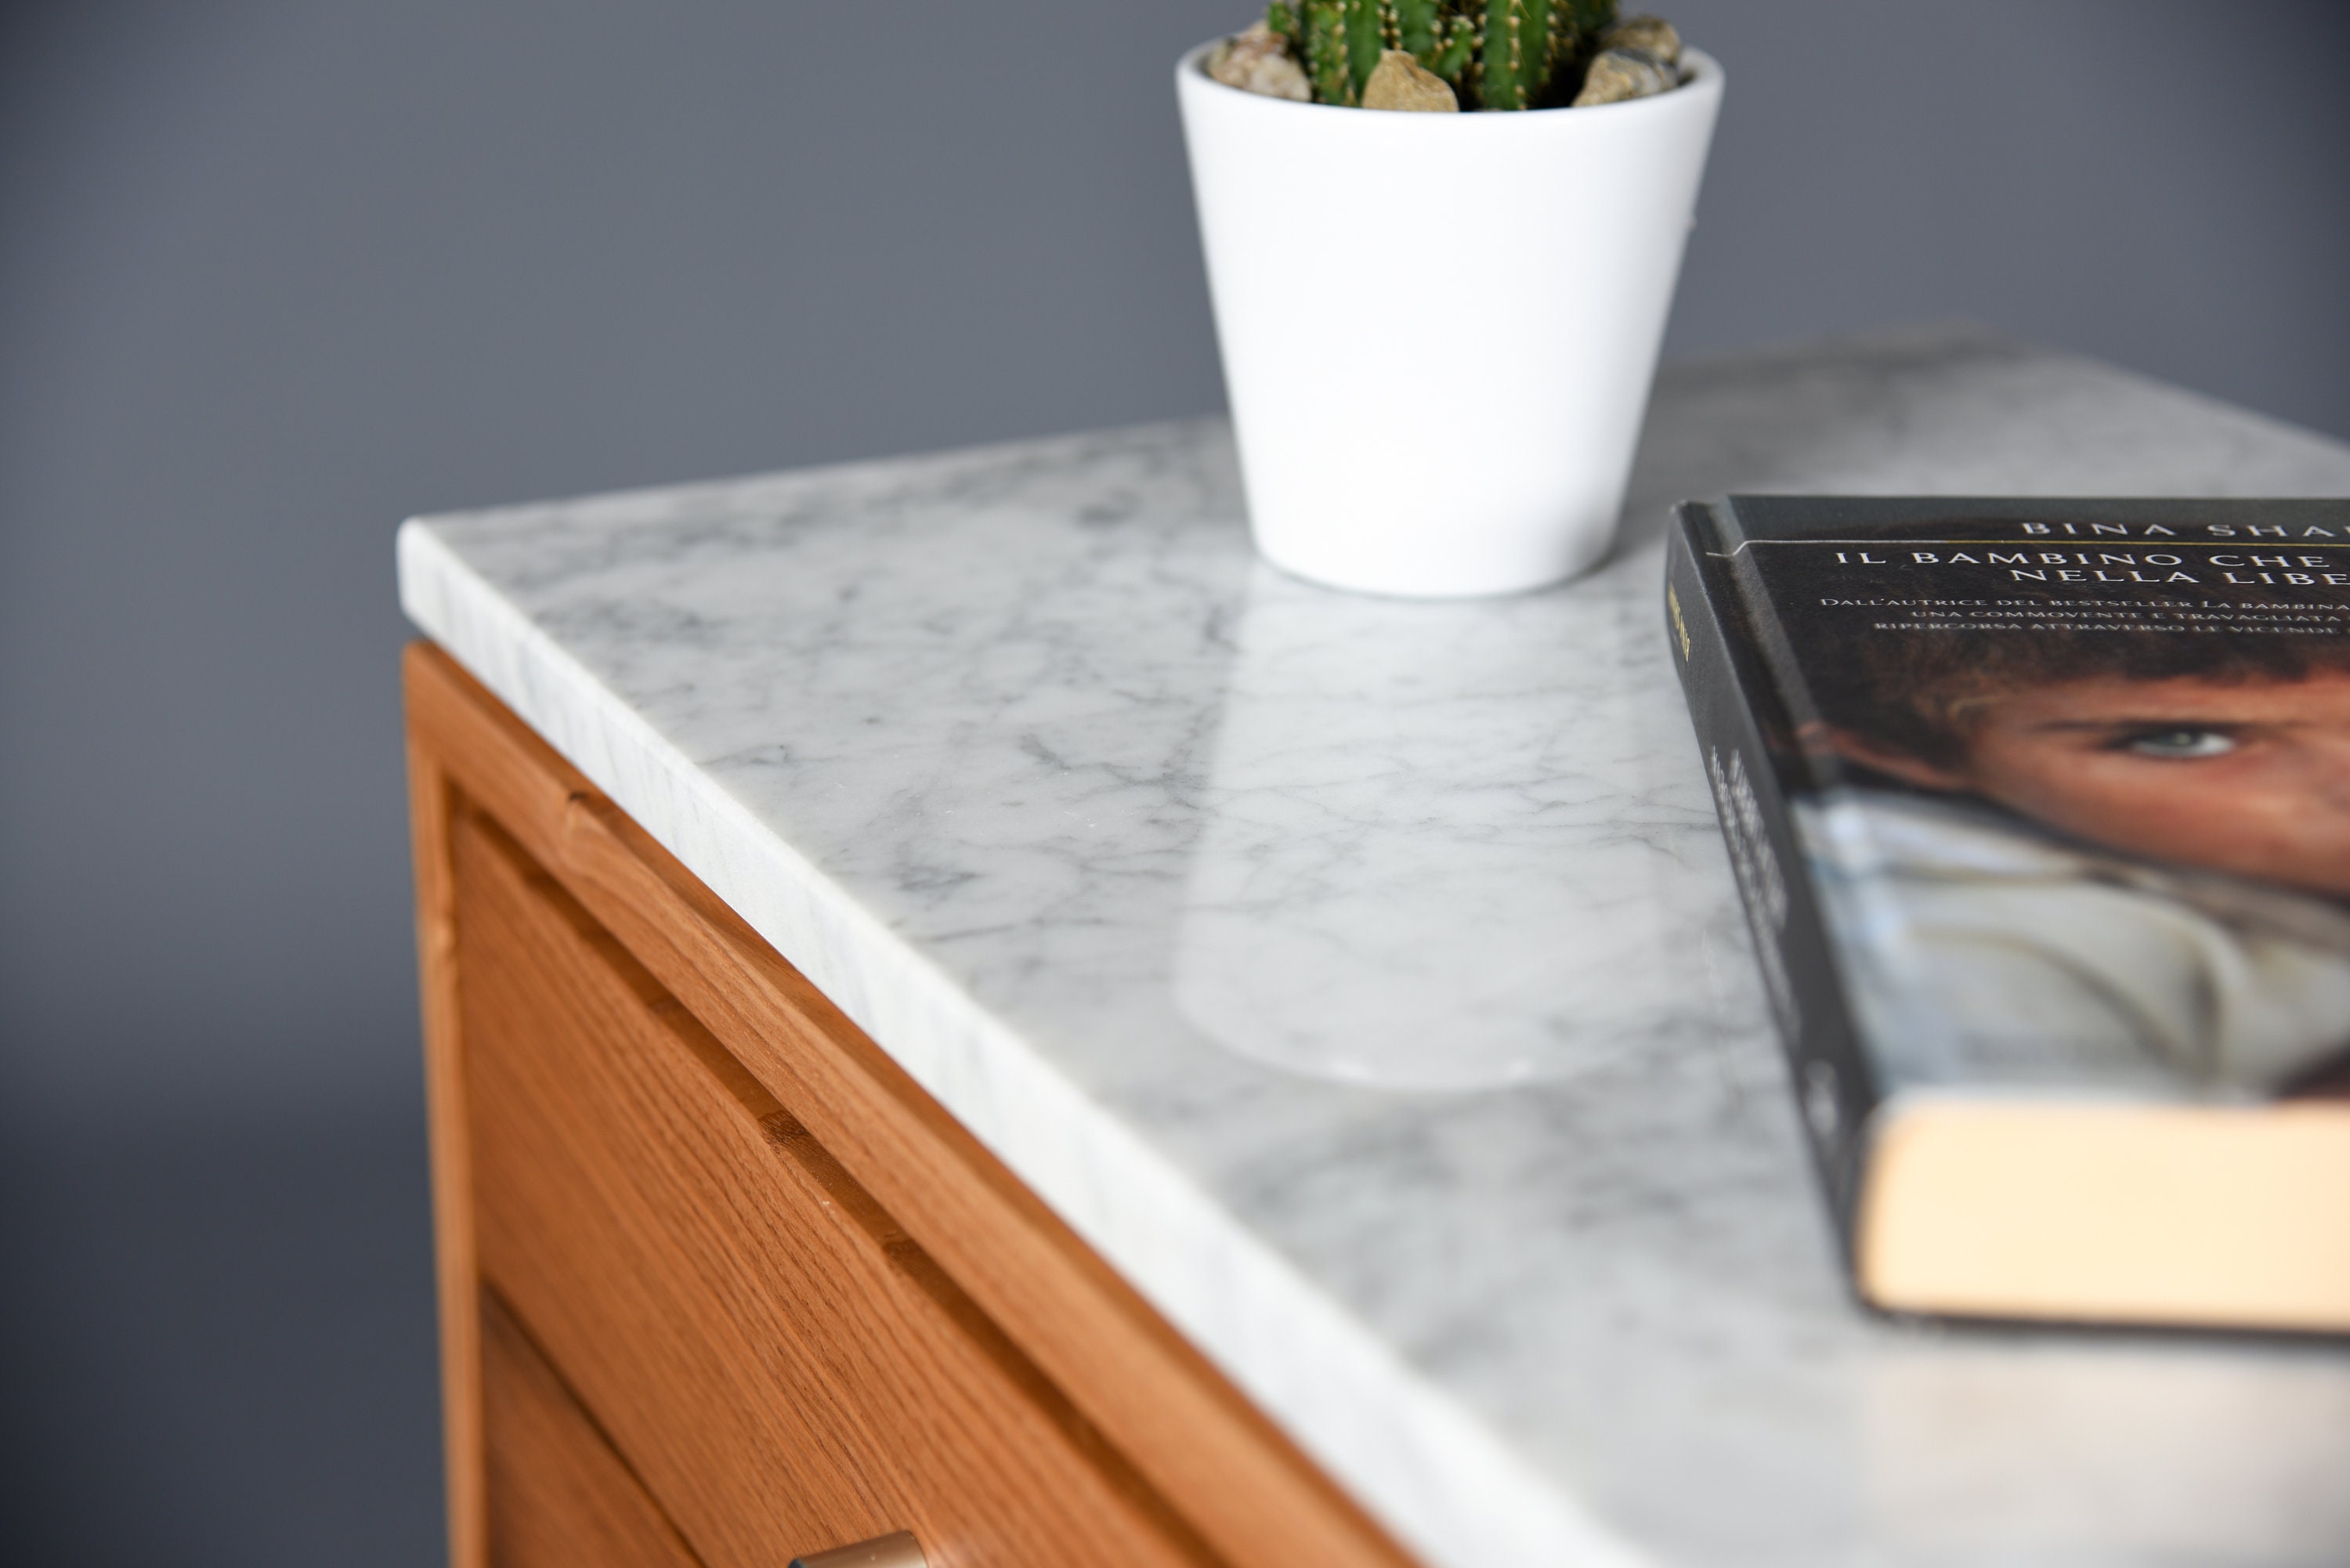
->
[1264, 0, 1617, 108]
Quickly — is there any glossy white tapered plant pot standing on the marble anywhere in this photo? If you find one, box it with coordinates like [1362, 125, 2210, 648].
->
[1175, 45, 1723, 597]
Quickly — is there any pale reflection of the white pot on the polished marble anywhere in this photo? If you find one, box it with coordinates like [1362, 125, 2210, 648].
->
[1175, 569, 1744, 1089]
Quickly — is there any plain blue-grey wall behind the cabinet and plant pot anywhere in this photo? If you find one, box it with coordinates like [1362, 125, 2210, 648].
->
[0, 0, 2350, 1563]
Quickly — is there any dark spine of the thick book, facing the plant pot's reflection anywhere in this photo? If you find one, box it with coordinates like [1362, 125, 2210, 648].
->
[1664, 503, 1878, 1265]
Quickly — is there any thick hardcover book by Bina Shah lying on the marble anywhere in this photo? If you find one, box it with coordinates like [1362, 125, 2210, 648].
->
[1664, 496, 2350, 1333]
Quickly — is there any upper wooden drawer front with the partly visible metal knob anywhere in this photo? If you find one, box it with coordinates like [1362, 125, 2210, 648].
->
[449, 814, 1215, 1568]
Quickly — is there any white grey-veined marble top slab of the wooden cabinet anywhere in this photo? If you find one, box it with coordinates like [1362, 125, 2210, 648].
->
[400, 331, 2350, 1568]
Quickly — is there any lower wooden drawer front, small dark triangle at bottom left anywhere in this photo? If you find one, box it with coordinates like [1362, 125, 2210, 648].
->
[482, 1291, 700, 1568]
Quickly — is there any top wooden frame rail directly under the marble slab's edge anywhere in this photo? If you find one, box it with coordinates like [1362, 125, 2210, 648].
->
[407, 644, 1412, 1568]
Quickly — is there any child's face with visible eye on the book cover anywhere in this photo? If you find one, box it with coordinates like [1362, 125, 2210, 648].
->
[1868, 672, 2350, 896]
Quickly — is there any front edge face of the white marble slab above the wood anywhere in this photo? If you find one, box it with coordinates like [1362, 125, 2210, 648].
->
[397, 512, 1652, 1568]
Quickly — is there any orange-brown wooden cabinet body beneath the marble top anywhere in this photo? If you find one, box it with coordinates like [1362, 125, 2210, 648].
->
[407, 644, 1408, 1568]
